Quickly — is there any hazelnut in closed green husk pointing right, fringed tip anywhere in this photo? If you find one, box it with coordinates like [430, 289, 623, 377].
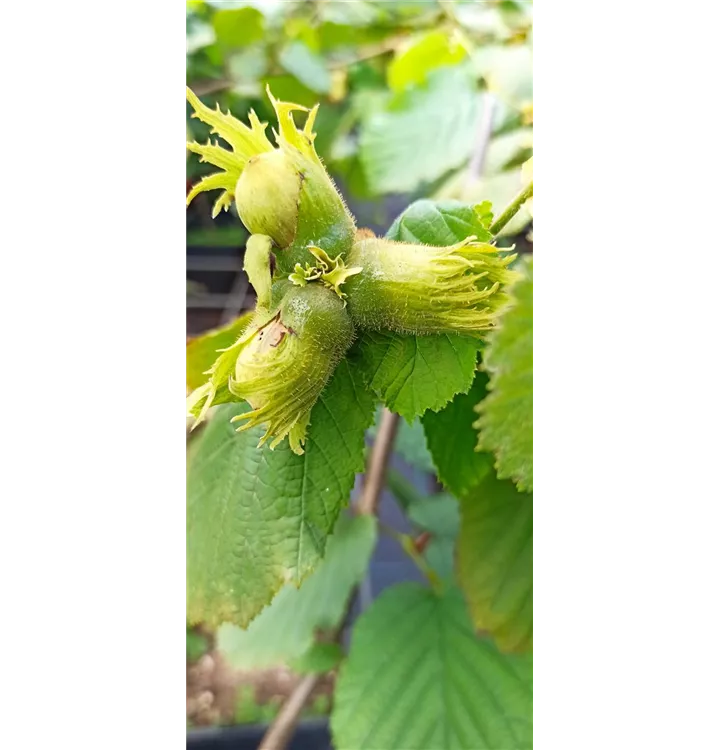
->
[344, 237, 516, 335]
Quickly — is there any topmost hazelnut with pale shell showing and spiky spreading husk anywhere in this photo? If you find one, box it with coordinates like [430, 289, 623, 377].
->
[187, 88, 356, 264]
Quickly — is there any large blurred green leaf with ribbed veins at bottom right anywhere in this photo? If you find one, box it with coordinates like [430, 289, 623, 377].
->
[331, 583, 534, 750]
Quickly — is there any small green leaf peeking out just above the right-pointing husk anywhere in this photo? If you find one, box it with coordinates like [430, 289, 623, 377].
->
[386, 200, 493, 247]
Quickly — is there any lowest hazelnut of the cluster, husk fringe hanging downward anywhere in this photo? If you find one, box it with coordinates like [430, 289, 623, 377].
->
[228, 284, 354, 454]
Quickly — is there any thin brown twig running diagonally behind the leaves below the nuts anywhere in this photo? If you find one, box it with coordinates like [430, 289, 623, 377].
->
[258, 409, 399, 750]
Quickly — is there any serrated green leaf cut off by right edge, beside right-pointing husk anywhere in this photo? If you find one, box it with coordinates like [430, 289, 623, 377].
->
[475, 256, 536, 492]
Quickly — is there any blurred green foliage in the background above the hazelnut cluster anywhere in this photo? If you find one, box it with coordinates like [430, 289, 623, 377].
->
[185, 0, 534, 238]
